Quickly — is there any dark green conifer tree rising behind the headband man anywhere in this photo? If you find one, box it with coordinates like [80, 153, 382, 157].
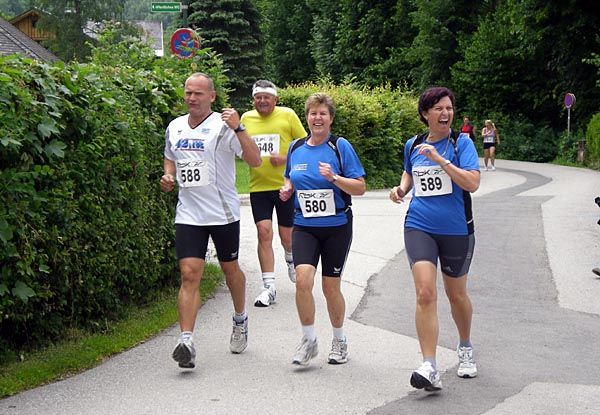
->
[188, 0, 264, 105]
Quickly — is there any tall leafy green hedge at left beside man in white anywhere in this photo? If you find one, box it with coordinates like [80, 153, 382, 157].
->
[0, 38, 227, 354]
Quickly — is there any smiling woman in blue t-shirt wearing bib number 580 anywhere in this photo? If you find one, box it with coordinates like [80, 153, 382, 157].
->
[280, 93, 366, 365]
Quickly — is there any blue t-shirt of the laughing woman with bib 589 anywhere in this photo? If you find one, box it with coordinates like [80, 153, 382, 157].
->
[404, 134, 479, 235]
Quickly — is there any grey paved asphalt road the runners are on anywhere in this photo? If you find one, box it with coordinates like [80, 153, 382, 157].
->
[0, 160, 600, 415]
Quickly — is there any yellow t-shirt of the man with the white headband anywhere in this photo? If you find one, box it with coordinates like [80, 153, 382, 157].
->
[241, 107, 307, 193]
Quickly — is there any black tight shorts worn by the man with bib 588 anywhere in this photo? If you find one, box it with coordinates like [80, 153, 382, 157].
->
[175, 221, 240, 262]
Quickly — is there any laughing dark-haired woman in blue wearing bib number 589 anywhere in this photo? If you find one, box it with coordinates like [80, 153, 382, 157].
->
[390, 87, 480, 391]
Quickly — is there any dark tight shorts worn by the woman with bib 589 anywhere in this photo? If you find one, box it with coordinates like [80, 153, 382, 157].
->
[406, 228, 475, 277]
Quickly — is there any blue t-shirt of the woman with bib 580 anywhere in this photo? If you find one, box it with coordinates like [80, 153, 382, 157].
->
[284, 137, 365, 227]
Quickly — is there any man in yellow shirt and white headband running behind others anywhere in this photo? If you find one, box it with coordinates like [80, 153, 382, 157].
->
[241, 80, 307, 307]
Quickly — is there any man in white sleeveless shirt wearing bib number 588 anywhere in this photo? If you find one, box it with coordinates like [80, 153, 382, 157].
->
[160, 73, 261, 369]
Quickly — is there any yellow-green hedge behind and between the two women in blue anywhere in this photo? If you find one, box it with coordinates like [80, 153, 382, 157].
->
[280, 82, 424, 188]
